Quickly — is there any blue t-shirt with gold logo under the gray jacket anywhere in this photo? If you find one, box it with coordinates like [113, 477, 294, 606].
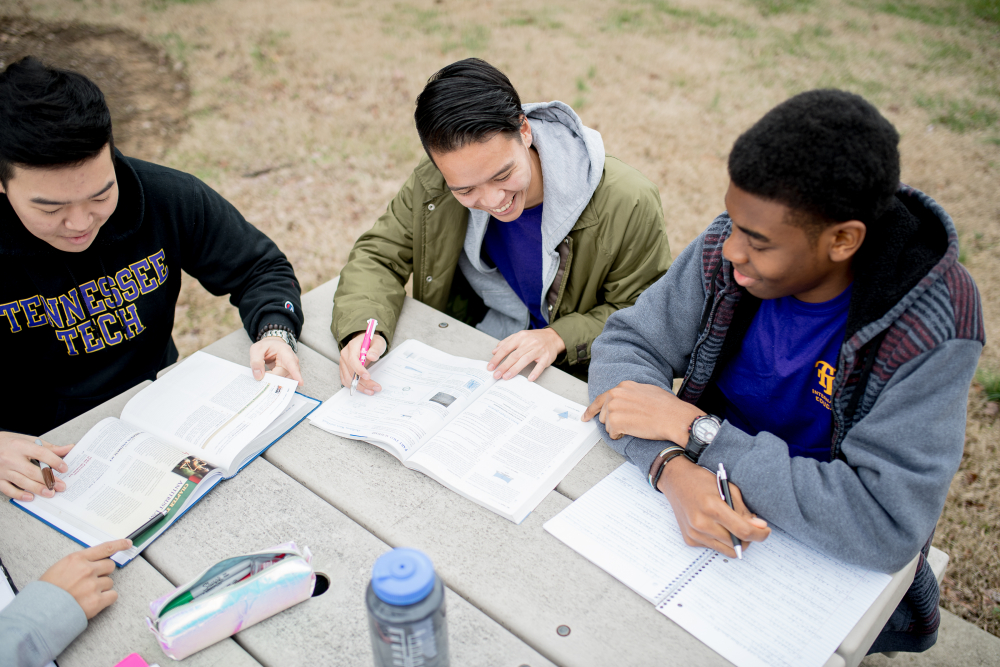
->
[718, 287, 851, 461]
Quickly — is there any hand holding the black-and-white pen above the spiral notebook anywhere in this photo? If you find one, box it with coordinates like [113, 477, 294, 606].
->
[657, 456, 771, 558]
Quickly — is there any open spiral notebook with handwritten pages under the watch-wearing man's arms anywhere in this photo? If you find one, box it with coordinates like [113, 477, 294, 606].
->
[545, 463, 891, 667]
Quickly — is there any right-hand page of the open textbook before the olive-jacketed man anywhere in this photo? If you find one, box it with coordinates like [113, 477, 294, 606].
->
[407, 375, 600, 523]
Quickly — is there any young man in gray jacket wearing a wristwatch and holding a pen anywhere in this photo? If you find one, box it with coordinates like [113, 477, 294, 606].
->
[583, 90, 984, 652]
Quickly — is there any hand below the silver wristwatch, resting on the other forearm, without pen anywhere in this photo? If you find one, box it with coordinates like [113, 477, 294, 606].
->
[580, 380, 705, 445]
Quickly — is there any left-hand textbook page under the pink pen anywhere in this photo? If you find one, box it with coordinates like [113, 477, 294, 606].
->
[309, 339, 496, 461]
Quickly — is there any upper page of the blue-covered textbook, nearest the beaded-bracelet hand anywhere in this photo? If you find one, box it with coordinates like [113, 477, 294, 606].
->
[121, 352, 298, 472]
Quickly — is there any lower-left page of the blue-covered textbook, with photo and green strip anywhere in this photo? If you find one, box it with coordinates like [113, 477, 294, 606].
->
[15, 417, 221, 549]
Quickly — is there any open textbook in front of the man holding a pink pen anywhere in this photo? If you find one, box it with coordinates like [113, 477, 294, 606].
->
[310, 340, 600, 523]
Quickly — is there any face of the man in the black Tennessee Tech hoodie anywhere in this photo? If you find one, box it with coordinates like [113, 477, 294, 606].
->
[2, 145, 118, 252]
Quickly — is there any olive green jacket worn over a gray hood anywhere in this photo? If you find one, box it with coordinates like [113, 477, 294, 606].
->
[330, 156, 670, 365]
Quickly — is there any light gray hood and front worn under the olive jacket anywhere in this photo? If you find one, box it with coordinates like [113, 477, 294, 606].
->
[458, 102, 604, 339]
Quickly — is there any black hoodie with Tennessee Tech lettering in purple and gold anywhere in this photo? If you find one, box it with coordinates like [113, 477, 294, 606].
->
[0, 151, 302, 435]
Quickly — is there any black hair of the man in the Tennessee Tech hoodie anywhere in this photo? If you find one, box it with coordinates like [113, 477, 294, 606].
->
[0, 56, 114, 188]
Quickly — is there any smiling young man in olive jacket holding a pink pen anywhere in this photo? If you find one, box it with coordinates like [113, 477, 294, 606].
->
[331, 58, 670, 394]
